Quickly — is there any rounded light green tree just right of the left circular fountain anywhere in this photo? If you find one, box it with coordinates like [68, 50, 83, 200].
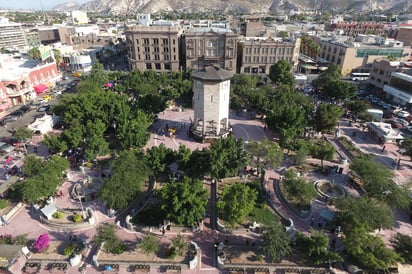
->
[99, 151, 150, 210]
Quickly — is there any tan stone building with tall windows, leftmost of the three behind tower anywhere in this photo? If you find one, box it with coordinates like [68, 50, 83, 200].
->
[125, 25, 180, 72]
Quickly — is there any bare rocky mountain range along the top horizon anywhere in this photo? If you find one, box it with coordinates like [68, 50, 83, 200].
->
[55, 0, 410, 14]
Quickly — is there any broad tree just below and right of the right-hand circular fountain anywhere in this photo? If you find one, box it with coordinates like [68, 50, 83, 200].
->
[335, 196, 394, 231]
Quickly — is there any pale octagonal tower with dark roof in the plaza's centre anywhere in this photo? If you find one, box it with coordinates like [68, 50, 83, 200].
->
[191, 66, 233, 141]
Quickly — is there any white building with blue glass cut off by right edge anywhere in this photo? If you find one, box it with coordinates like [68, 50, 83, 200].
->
[383, 72, 412, 106]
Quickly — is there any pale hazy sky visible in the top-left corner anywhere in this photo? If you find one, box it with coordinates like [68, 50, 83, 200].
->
[0, 0, 90, 10]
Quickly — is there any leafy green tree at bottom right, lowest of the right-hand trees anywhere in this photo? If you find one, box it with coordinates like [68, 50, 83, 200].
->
[343, 223, 402, 270]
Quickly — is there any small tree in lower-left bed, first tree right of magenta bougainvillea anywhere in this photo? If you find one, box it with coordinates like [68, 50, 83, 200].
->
[94, 223, 126, 254]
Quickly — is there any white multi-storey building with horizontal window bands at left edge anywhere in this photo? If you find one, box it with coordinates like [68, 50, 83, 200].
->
[0, 23, 27, 49]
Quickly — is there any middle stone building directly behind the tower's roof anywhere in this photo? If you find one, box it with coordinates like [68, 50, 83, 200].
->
[182, 28, 239, 73]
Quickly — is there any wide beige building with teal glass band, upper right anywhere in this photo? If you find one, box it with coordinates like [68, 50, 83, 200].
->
[315, 35, 412, 76]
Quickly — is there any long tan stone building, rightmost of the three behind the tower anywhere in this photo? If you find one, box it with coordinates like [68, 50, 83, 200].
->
[237, 37, 301, 74]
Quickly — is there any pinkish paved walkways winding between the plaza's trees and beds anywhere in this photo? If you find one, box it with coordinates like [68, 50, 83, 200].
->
[2, 110, 412, 274]
